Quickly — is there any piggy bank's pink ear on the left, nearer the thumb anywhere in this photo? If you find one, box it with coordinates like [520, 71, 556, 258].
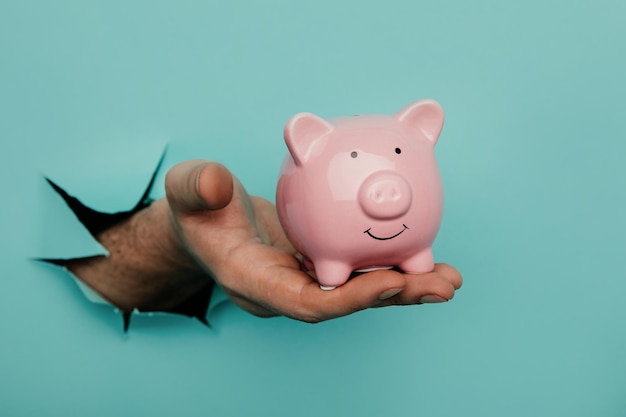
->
[285, 113, 333, 165]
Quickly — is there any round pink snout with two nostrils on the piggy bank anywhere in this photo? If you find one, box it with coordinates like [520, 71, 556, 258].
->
[359, 171, 413, 220]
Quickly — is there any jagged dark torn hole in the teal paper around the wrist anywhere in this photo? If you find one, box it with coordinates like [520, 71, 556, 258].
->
[37, 148, 228, 331]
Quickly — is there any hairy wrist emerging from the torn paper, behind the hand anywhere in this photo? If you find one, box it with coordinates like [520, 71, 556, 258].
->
[67, 199, 211, 311]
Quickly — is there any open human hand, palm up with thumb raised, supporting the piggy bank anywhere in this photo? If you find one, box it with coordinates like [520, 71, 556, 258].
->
[166, 160, 462, 323]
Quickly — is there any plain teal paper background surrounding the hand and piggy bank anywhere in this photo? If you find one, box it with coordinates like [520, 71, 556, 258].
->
[0, 0, 626, 417]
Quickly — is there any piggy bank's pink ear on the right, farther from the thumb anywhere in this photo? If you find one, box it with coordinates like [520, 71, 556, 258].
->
[396, 99, 443, 146]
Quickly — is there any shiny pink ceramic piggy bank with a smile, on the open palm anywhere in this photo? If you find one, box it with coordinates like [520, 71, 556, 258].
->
[276, 100, 443, 289]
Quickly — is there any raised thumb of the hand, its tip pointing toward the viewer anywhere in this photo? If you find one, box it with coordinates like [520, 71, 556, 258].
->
[165, 160, 233, 212]
